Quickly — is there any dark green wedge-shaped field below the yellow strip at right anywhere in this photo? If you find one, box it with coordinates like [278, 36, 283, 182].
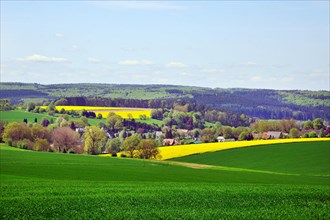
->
[172, 141, 330, 176]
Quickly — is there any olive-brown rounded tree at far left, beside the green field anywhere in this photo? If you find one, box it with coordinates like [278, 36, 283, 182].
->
[2, 122, 32, 146]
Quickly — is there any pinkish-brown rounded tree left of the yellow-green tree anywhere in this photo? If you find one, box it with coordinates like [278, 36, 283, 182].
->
[51, 127, 80, 153]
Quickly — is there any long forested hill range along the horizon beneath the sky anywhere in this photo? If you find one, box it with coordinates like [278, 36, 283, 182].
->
[0, 82, 330, 120]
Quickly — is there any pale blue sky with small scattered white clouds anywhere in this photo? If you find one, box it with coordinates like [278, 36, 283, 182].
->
[0, 0, 330, 91]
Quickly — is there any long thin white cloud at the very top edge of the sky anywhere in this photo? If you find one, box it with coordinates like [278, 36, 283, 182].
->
[93, 1, 182, 10]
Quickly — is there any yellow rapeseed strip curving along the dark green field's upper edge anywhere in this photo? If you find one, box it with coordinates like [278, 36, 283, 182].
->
[159, 138, 330, 160]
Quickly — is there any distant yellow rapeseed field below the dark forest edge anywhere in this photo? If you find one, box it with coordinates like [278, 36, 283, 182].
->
[40, 105, 152, 118]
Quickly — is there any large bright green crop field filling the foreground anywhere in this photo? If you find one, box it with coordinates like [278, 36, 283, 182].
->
[0, 144, 330, 219]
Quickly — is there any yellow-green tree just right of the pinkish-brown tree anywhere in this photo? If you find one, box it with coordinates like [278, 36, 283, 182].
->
[83, 126, 106, 155]
